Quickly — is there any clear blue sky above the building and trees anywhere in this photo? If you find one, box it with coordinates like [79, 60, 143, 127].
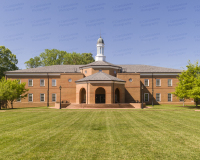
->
[0, 0, 200, 69]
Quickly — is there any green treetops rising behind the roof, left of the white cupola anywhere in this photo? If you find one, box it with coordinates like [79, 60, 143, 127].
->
[25, 49, 94, 68]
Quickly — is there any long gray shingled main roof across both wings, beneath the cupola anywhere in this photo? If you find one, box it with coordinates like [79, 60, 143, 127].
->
[7, 64, 182, 73]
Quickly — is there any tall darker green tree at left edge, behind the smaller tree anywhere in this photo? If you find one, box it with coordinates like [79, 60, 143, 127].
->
[0, 46, 19, 79]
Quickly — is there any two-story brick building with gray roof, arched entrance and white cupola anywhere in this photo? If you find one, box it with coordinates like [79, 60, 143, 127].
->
[6, 37, 191, 107]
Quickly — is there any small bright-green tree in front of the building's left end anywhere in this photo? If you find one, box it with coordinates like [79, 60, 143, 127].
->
[0, 77, 28, 108]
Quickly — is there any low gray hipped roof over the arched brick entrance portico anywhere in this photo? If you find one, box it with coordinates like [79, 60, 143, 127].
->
[76, 72, 126, 82]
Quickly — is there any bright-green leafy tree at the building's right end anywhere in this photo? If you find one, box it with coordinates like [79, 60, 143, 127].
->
[172, 61, 200, 107]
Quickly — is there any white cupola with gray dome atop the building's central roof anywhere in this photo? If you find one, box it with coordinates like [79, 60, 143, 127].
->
[95, 36, 106, 61]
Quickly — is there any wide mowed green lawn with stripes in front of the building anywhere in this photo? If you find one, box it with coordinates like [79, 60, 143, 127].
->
[0, 106, 200, 159]
